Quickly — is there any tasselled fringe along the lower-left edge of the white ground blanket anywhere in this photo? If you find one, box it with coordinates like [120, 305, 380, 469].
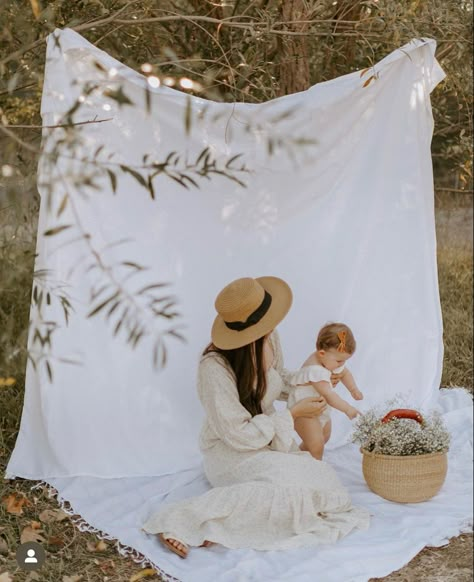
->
[30, 481, 181, 582]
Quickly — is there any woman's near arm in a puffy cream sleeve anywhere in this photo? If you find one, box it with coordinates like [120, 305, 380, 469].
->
[198, 356, 294, 452]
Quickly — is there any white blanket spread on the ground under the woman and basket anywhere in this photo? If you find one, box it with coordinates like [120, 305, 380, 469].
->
[43, 388, 473, 582]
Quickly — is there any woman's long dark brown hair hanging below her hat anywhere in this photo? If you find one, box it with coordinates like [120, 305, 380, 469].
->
[202, 336, 267, 416]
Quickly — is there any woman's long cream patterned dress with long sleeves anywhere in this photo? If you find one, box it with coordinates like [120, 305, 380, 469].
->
[143, 331, 369, 550]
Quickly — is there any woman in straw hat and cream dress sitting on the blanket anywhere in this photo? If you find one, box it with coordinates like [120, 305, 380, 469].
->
[144, 277, 369, 558]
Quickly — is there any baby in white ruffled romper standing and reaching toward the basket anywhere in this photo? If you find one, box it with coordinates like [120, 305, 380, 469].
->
[288, 323, 363, 460]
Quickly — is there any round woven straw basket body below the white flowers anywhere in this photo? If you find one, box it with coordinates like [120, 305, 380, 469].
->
[360, 449, 448, 503]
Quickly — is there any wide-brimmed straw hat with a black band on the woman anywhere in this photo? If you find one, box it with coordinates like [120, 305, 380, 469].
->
[211, 277, 293, 350]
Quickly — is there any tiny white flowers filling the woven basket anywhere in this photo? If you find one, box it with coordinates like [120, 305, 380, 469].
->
[352, 397, 450, 456]
